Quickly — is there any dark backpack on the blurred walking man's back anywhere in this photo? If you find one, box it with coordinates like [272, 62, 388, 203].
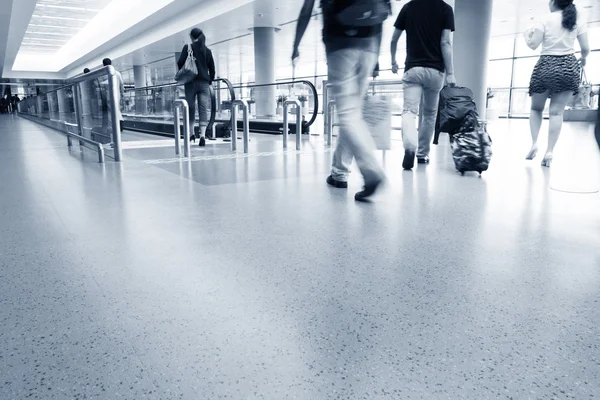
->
[321, 0, 392, 28]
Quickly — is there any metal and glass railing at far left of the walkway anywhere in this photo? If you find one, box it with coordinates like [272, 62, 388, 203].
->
[19, 66, 122, 161]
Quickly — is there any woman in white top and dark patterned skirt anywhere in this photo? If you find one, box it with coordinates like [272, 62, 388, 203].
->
[525, 0, 590, 167]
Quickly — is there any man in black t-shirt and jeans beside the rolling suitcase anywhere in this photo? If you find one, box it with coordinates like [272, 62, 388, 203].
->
[391, 0, 456, 170]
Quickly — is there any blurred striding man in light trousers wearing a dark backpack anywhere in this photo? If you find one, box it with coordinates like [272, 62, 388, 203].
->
[292, 0, 391, 201]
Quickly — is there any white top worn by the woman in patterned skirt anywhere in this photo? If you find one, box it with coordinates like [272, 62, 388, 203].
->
[525, 11, 587, 56]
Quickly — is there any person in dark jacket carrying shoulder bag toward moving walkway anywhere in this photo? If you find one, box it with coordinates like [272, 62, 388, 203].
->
[177, 28, 216, 146]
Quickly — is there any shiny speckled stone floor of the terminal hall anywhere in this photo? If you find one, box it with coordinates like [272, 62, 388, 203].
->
[0, 116, 600, 400]
